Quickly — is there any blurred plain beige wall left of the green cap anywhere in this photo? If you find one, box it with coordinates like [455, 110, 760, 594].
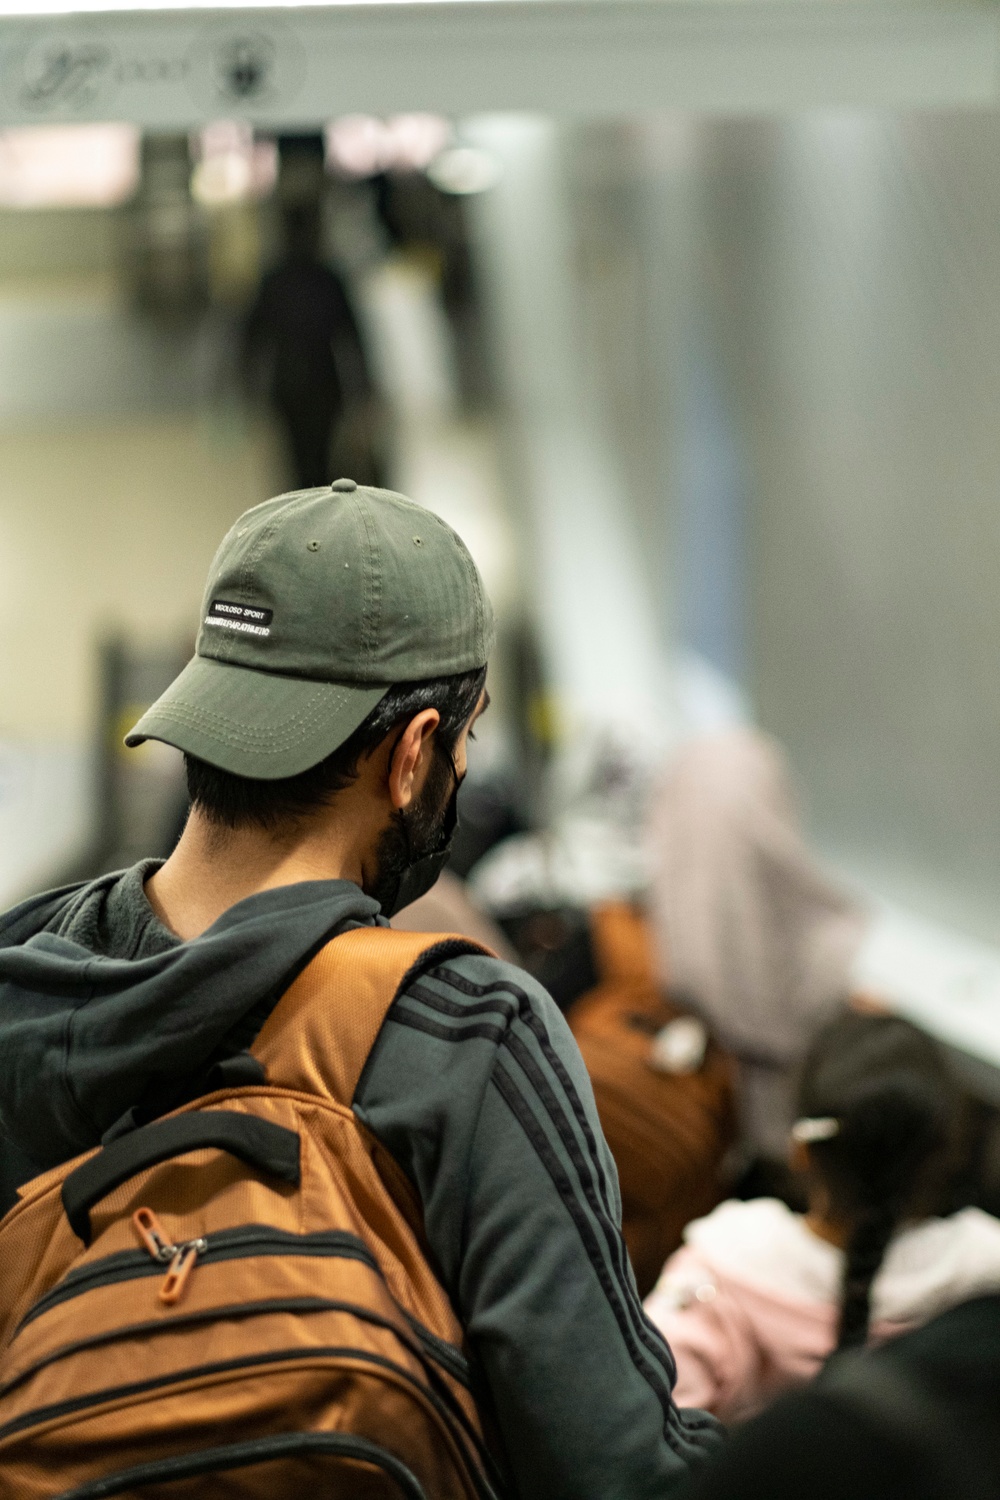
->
[0, 416, 280, 743]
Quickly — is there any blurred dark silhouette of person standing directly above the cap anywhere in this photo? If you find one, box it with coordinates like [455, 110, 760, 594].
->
[244, 201, 379, 489]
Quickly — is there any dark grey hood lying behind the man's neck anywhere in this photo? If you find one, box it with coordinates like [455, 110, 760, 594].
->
[0, 872, 381, 1170]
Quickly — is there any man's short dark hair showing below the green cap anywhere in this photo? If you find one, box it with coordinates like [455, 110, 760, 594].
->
[184, 666, 486, 830]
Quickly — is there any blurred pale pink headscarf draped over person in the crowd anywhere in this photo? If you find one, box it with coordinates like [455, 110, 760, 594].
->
[649, 729, 865, 1157]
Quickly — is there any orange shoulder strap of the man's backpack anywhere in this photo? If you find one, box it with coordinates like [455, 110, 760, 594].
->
[250, 927, 490, 1109]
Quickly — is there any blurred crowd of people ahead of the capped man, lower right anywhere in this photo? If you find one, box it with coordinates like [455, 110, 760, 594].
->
[396, 728, 1000, 1497]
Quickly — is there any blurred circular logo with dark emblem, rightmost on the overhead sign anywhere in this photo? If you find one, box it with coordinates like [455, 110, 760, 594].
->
[190, 24, 306, 113]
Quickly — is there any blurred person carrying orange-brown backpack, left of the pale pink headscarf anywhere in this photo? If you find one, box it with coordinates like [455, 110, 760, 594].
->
[472, 726, 735, 1295]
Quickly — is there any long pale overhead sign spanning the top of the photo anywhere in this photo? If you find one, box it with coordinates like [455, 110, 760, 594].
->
[0, 0, 1000, 129]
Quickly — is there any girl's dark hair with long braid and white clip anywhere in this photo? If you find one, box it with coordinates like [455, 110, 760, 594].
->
[799, 1013, 961, 1349]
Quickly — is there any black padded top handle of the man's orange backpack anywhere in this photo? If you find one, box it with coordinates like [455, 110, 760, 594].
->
[63, 1110, 301, 1245]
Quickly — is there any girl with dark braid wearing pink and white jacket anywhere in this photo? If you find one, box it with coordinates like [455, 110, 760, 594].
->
[645, 1013, 1000, 1422]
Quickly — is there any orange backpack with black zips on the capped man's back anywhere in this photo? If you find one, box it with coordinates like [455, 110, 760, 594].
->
[0, 927, 496, 1500]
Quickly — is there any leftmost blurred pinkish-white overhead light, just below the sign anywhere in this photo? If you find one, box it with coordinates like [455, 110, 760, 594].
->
[0, 125, 139, 209]
